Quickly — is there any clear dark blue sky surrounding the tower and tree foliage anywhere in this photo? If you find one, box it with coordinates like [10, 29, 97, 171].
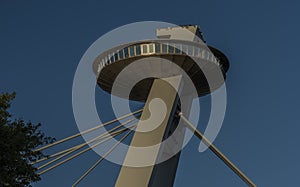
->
[0, 0, 300, 187]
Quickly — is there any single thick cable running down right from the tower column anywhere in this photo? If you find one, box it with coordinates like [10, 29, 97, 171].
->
[179, 112, 256, 187]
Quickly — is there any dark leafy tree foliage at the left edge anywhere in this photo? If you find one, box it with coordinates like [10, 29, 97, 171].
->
[0, 93, 54, 187]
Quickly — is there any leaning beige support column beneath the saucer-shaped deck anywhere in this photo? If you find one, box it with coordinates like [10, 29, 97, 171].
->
[115, 76, 184, 187]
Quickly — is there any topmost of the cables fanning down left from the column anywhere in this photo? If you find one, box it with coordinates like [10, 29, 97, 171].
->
[34, 109, 143, 151]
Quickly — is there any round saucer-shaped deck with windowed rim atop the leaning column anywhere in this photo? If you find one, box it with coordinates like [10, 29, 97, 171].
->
[93, 40, 229, 101]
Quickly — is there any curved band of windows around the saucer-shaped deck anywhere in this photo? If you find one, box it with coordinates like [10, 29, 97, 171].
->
[99, 43, 219, 71]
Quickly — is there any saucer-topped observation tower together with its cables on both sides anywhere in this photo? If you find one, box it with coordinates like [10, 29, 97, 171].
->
[31, 25, 255, 187]
